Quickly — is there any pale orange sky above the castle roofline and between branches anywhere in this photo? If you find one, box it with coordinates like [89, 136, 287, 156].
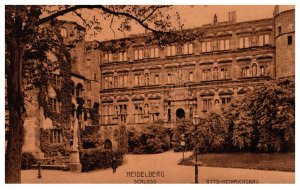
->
[56, 5, 295, 41]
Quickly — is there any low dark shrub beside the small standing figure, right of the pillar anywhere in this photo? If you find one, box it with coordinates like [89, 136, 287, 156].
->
[80, 148, 123, 172]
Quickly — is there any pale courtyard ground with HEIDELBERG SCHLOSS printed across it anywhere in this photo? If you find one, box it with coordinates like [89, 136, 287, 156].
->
[22, 151, 295, 183]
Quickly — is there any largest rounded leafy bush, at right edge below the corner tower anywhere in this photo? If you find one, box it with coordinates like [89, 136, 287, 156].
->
[223, 79, 295, 152]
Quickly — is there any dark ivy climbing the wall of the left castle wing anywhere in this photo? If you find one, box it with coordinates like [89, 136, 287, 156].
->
[38, 46, 73, 156]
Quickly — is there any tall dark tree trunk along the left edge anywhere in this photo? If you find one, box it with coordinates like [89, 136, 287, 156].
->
[5, 38, 26, 183]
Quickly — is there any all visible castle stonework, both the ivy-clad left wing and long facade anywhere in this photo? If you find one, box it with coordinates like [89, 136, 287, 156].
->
[15, 7, 295, 159]
